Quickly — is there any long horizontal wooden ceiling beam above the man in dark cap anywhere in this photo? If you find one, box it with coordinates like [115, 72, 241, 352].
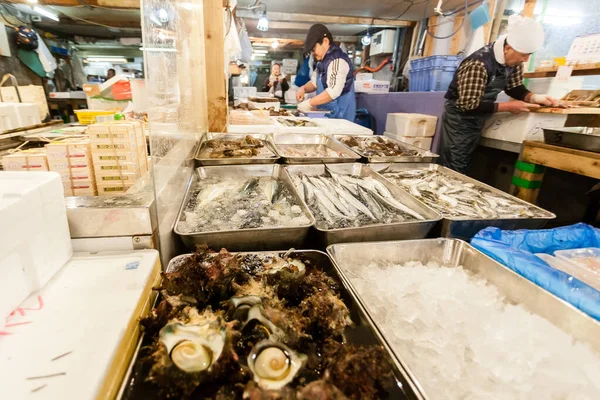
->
[244, 11, 415, 27]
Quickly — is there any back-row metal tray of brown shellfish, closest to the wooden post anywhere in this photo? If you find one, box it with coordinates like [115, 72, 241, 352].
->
[196, 133, 279, 166]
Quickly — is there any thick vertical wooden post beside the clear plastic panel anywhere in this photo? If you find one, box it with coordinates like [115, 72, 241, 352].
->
[203, 0, 227, 132]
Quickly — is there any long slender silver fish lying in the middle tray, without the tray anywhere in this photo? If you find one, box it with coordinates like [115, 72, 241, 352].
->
[292, 168, 425, 229]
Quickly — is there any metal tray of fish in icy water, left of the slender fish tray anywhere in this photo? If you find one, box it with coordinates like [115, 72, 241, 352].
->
[175, 165, 314, 250]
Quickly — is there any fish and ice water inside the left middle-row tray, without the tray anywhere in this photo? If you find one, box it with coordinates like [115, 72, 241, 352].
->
[178, 177, 310, 233]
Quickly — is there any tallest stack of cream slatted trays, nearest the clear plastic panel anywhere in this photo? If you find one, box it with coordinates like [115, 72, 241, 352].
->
[88, 121, 148, 196]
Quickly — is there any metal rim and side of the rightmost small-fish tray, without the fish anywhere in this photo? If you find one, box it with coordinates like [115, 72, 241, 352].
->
[369, 163, 556, 240]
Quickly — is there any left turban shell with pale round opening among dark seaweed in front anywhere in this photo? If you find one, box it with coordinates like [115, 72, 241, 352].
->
[159, 312, 226, 372]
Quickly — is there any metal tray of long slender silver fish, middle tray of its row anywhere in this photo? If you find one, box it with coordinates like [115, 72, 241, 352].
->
[285, 163, 440, 245]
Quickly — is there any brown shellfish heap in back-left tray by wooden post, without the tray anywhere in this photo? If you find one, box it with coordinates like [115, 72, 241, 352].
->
[199, 135, 275, 159]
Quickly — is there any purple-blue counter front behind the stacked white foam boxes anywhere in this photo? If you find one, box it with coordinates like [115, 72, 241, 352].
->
[356, 92, 446, 149]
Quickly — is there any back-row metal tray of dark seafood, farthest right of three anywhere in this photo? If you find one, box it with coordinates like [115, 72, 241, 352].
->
[333, 135, 439, 163]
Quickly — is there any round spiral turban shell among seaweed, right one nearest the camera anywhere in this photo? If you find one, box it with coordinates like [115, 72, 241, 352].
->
[248, 340, 307, 390]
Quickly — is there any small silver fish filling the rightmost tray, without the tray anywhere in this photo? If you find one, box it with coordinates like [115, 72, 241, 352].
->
[380, 169, 547, 219]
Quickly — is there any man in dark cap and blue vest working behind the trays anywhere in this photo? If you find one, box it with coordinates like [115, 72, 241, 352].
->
[296, 24, 356, 122]
